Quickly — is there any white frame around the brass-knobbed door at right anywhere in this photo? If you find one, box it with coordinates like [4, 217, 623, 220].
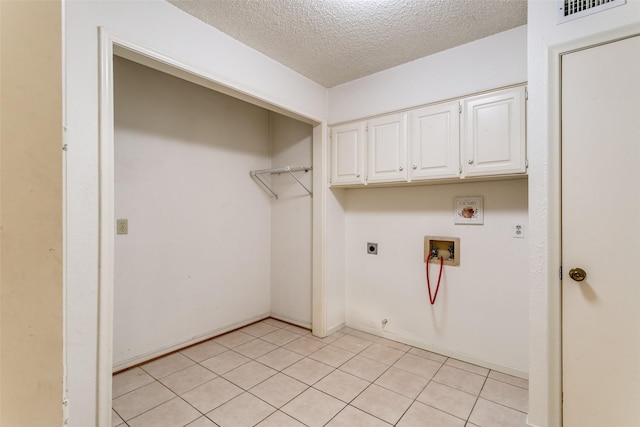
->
[544, 24, 640, 426]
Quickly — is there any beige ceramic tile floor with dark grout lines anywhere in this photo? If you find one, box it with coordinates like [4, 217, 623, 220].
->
[112, 319, 528, 427]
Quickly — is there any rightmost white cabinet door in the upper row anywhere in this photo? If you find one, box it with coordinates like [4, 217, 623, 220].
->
[461, 87, 527, 177]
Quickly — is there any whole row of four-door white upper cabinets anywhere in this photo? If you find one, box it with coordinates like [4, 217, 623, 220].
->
[331, 86, 527, 186]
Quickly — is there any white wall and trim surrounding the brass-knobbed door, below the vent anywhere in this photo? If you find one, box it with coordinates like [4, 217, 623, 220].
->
[528, 0, 640, 427]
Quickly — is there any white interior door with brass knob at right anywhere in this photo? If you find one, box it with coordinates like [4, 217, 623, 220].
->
[562, 36, 640, 427]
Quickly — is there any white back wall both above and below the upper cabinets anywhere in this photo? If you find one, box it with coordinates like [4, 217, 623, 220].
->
[329, 27, 528, 376]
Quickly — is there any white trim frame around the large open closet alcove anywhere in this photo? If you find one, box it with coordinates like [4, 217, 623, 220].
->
[96, 27, 329, 427]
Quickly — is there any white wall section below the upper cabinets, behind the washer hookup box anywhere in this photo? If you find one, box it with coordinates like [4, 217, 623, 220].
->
[346, 179, 528, 377]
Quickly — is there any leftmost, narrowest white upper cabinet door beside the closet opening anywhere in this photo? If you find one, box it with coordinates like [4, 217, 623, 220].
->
[331, 122, 366, 185]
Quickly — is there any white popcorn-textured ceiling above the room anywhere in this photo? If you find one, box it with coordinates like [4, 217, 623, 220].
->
[168, 0, 527, 88]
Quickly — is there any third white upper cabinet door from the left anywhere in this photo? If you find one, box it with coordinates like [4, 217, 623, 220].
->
[409, 102, 460, 181]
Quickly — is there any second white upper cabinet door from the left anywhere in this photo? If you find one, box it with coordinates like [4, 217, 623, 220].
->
[367, 113, 407, 183]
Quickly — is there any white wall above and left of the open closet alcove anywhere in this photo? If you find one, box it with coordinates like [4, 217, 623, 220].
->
[63, 0, 326, 426]
